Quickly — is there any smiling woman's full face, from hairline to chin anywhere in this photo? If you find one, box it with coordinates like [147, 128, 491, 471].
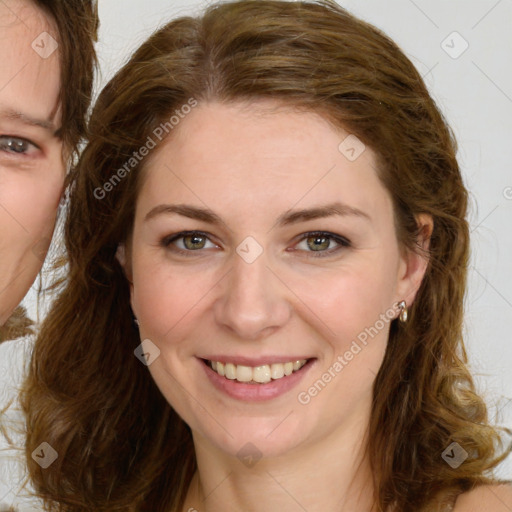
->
[120, 102, 425, 456]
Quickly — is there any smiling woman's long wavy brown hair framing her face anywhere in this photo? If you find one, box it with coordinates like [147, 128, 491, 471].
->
[22, 0, 504, 512]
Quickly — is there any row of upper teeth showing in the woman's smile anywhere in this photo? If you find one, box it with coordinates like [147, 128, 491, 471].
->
[209, 359, 307, 384]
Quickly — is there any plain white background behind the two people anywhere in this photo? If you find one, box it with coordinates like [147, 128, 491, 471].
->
[16, 0, 512, 492]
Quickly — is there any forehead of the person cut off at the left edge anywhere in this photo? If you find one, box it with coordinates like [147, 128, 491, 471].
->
[0, 0, 60, 123]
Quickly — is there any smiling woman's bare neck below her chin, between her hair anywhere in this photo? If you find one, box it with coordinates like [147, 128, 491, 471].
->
[183, 404, 374, 512]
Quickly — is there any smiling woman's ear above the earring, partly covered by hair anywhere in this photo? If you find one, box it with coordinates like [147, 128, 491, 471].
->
[397, 214, 434, 306]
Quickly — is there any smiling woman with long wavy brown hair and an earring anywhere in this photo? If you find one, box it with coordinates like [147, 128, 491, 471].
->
[23, 0, 511, 512]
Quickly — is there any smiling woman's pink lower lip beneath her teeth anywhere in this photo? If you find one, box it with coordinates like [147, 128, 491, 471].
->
[199, 359, 315, 402]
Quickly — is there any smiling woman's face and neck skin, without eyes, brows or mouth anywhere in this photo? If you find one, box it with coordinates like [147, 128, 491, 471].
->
[118, 101, 510, 512]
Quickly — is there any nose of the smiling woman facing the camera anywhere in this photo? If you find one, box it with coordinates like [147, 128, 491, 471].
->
[214, 255, 291, 340]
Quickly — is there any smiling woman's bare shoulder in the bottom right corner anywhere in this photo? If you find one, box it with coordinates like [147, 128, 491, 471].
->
[454, 484, 512, 512]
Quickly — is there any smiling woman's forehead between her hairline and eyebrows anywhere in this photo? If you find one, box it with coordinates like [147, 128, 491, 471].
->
[139, 102, 391, 225]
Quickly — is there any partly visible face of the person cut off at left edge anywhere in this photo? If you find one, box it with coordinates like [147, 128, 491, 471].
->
[0, 0, 65, 325]
